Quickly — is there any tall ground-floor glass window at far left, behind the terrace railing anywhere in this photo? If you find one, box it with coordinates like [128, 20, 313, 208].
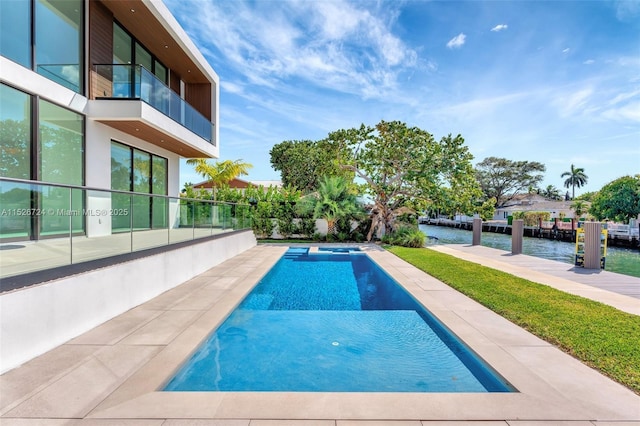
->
[0, 85, 84, 238]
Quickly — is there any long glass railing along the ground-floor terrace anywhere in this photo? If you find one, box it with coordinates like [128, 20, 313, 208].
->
[0, 178, 251, 279]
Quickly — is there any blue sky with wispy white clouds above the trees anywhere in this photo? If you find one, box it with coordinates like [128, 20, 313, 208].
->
[164, 0, 640, 194]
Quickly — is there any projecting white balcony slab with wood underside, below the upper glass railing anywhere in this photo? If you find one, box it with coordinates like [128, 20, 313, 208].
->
[87, 99, 219, 158]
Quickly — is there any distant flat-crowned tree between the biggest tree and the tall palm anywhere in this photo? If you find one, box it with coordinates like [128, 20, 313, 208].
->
[476, 157, 546, 206]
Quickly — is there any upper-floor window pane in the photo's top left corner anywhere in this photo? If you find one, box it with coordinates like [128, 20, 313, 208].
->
[0, 0, 31, 68]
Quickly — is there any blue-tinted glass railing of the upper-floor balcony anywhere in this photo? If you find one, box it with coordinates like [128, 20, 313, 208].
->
[94, 64, 215, 144]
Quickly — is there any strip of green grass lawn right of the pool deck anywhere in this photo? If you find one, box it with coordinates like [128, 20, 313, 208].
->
[387, 247, 640, 394]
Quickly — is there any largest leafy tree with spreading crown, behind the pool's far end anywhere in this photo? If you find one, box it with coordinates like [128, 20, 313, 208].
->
[327, 121, 481, 240]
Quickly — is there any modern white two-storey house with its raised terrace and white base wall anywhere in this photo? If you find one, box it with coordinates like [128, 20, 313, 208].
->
[0, 0, 255, 372]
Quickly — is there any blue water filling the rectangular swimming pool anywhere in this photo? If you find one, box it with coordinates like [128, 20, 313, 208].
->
[164, 248, 514, 392]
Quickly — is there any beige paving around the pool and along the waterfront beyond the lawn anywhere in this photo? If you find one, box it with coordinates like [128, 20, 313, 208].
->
[0, 245, 640, 426]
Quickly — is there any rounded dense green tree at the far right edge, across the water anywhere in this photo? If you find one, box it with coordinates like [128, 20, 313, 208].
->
[589, 174, 640, 222]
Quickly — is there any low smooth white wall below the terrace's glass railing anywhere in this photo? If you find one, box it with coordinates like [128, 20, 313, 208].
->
[0, 230, 256, 373]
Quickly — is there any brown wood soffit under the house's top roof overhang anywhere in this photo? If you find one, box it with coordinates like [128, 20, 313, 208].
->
[102, 0, 210, 83]
